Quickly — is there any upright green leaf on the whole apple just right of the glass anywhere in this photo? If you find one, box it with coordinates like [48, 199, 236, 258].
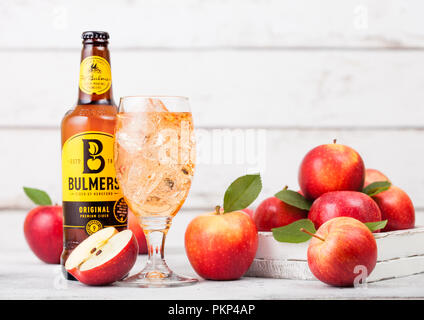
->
[224, 173, 262, 213]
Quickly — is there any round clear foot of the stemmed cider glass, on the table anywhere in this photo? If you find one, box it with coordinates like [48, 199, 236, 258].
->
[114, 271, 198, 288]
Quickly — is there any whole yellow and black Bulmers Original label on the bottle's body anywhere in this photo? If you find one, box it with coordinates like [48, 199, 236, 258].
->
[62, 131, 128, 235]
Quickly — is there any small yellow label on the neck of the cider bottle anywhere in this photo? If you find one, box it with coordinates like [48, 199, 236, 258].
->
[79, 56, 112, 94]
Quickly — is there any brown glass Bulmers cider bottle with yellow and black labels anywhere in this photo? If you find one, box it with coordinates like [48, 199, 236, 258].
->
[61, 31, 128, 279]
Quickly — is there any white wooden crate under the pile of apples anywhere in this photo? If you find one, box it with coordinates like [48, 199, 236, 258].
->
[246, 227, 424, 282]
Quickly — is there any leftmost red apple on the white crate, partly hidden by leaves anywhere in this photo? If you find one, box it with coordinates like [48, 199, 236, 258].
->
[253, 197, 308, 231]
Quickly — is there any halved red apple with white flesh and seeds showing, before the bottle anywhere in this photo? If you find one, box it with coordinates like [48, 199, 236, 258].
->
[65, 227, 138, 286]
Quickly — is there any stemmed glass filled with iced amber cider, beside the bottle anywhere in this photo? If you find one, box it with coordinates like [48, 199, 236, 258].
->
[114, 96, 197, 287]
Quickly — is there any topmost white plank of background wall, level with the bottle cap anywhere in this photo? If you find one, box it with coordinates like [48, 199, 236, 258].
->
[0, 0, 424, 48]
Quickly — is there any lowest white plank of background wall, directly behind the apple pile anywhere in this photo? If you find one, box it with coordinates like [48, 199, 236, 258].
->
[0, 129, 424, 211]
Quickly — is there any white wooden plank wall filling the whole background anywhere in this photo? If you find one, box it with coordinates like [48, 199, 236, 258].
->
[0, 0, 424, 220]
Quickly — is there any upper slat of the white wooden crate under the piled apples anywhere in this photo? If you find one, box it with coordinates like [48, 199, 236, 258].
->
[256, 226, 424, 262]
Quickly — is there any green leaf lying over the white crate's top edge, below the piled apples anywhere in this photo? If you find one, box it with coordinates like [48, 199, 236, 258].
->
[272, 219, 316, 243]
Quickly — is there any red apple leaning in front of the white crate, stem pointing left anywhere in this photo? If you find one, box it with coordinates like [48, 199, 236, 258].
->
[308, 217, 377, 286]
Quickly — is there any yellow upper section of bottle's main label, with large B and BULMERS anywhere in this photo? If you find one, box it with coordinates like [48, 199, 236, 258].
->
[62, 131, 122, 201]
